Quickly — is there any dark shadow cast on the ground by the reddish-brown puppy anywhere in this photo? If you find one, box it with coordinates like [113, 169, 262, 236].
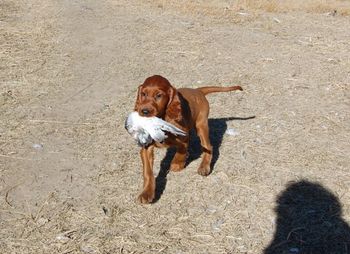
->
[154, 116, 255, 202]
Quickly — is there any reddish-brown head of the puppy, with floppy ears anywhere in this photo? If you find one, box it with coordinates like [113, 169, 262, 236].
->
[134, 75, 179, 118]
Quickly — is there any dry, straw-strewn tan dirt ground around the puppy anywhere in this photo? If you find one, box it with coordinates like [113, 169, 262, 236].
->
[0, 0, 350, 254]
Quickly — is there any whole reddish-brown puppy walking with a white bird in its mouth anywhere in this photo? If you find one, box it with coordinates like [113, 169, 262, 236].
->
[135, 75, 242, 203]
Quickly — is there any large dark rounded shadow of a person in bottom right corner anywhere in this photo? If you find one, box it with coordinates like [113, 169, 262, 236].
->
[264, 180, 350, 254]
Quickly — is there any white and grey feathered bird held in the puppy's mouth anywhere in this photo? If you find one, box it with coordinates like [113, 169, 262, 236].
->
[125, 112, 186, 146]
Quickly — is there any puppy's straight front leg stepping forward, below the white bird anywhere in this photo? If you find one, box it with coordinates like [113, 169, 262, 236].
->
[139, 145, 156, 204]
